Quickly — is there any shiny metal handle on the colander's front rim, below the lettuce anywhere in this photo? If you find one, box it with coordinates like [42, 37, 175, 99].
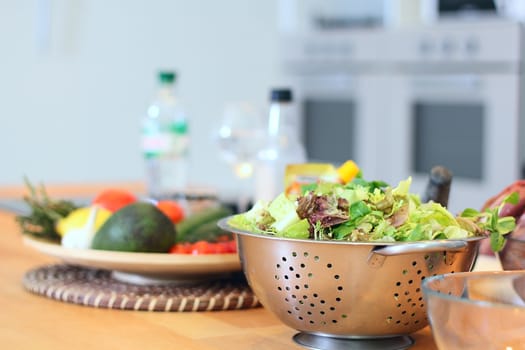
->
[373, 240, 468, 256]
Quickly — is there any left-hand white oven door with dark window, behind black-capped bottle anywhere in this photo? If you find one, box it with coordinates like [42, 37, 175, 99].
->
[294, 73, 387, 178]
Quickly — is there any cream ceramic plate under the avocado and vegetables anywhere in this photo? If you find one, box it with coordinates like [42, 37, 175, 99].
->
[23, 236, 241, 283]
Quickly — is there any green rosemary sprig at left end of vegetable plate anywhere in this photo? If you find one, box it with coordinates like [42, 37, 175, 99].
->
[16, 177, 78, 241]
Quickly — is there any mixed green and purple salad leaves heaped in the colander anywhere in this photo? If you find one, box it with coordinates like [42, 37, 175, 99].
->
[229, 177, 517, 251]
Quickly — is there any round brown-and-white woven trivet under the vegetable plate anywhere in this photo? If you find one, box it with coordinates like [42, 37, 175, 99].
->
[23, 264, 260, 311]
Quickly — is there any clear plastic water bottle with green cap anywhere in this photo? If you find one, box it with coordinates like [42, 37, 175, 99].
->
[141, 71, 189, 199]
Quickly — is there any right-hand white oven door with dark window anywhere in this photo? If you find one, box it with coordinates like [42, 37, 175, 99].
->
[382, 73, 523, 213]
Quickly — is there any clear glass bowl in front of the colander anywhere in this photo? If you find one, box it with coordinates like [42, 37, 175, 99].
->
[422, 271, 525, 350]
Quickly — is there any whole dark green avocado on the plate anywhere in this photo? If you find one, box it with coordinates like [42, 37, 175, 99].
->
[91, 202, 176, 253]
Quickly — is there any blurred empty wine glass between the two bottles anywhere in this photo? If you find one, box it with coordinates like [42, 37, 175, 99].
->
[216, 102, 265, 212]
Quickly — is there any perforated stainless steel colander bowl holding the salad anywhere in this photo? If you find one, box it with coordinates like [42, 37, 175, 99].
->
[219, 218, 482, 338]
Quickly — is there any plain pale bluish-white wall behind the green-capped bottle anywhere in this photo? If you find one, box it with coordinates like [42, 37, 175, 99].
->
[0, 0, 281, 197]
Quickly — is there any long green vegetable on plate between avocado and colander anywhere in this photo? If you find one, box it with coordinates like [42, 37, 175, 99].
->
[175, 205, 233, 243]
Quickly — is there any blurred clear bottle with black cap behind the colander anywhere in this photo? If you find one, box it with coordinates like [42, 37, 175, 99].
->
[255, 88, 306, 201]
